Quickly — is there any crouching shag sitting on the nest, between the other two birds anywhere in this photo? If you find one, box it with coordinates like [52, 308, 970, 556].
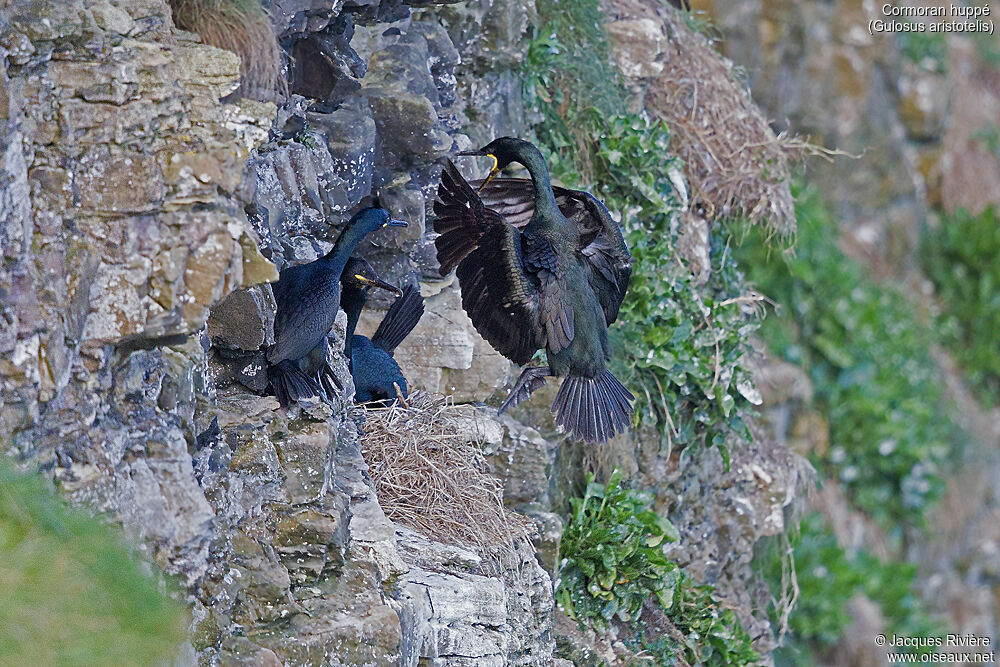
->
[340, 257, 424, 403]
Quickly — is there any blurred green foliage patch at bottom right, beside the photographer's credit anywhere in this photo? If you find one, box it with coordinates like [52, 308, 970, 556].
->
[765, 513, 941, 664]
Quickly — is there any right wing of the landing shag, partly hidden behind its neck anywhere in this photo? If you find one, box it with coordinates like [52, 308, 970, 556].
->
[471, 178, 632, 324]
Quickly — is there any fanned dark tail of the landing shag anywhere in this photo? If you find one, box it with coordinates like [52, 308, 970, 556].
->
[552, 370, 635, 442]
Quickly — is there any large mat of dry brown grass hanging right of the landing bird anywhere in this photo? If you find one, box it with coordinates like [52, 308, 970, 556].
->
[646, 13, 810, 237]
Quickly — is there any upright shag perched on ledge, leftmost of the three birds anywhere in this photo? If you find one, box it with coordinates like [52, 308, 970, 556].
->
[267, 207, 406, 406]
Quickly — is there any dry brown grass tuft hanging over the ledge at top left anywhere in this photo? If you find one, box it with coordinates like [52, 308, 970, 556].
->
[170, 0, 286, 101]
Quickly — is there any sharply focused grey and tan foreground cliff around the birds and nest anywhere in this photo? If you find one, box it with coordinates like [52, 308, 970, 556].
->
[0, 0, 799, 665]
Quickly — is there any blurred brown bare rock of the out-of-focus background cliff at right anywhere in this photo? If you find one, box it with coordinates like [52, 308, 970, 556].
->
[697, 0, 1000, 665]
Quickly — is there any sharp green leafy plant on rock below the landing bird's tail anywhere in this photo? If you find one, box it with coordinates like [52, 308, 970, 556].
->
[556, 471, 759, 665]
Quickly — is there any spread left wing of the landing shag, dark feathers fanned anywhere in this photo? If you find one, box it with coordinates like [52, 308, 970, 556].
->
[434, 160, 544, 365]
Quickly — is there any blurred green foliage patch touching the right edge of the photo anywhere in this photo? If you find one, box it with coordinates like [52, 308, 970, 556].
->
[922, 207, 1000, 404]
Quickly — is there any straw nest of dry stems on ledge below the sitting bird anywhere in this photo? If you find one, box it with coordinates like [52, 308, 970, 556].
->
[361, 392, 533, 556]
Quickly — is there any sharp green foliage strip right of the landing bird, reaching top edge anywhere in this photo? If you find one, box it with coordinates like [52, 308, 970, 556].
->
[524, 0, 756, 456]
